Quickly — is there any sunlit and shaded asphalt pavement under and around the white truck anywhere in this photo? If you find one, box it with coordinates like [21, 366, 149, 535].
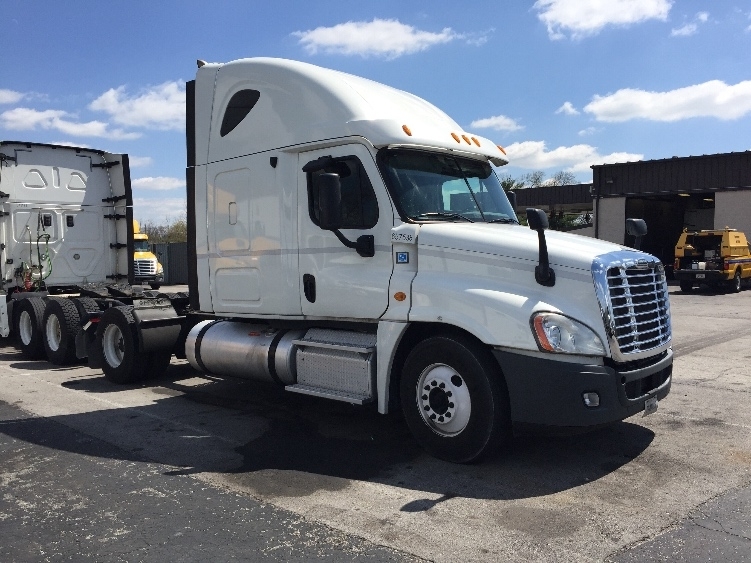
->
[0, 288, 751, 563]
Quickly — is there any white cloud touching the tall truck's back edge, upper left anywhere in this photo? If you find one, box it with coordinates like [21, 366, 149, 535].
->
[89, 80, 185, 131]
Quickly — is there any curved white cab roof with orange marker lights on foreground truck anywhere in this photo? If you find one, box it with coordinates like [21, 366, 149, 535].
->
[195, 58, 508, 166]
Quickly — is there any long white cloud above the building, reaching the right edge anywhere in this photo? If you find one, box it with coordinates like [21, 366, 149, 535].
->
[584, 80, 751, 123]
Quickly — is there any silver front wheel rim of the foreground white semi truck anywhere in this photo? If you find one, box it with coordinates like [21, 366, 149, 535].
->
[417, 364, 472, 436]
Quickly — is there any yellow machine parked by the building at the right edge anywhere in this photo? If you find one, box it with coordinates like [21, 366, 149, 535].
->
[673, 227, 751, 292]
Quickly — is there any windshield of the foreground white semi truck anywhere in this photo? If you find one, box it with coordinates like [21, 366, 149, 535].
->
[378, 149, 518, 223]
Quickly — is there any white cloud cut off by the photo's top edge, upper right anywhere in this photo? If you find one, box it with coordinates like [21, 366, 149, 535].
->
[533, 0, 672, 39]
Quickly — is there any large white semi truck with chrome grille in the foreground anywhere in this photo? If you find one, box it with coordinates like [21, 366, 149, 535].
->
[8, 58, 673, 462]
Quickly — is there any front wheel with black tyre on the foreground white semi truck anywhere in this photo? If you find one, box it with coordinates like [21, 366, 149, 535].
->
[400, 336, 511, 463]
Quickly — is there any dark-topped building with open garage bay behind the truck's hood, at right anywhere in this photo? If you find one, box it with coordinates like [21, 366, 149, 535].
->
[516, 151, 751, 265]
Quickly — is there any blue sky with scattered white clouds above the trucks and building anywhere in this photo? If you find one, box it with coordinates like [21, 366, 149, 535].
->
[0, 0, 751, 222]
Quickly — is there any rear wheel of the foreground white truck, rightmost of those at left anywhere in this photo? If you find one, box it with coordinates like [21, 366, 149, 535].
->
[96, 305, 150, 383]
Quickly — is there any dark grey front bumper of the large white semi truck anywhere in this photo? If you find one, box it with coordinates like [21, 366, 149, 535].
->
[493, 350, 673, 428]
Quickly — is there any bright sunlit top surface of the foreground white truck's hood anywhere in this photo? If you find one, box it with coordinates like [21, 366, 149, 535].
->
[417, 222, 643, 271]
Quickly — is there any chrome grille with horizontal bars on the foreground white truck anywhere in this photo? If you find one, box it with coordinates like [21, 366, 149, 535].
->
[607, 262, 671, 354]
